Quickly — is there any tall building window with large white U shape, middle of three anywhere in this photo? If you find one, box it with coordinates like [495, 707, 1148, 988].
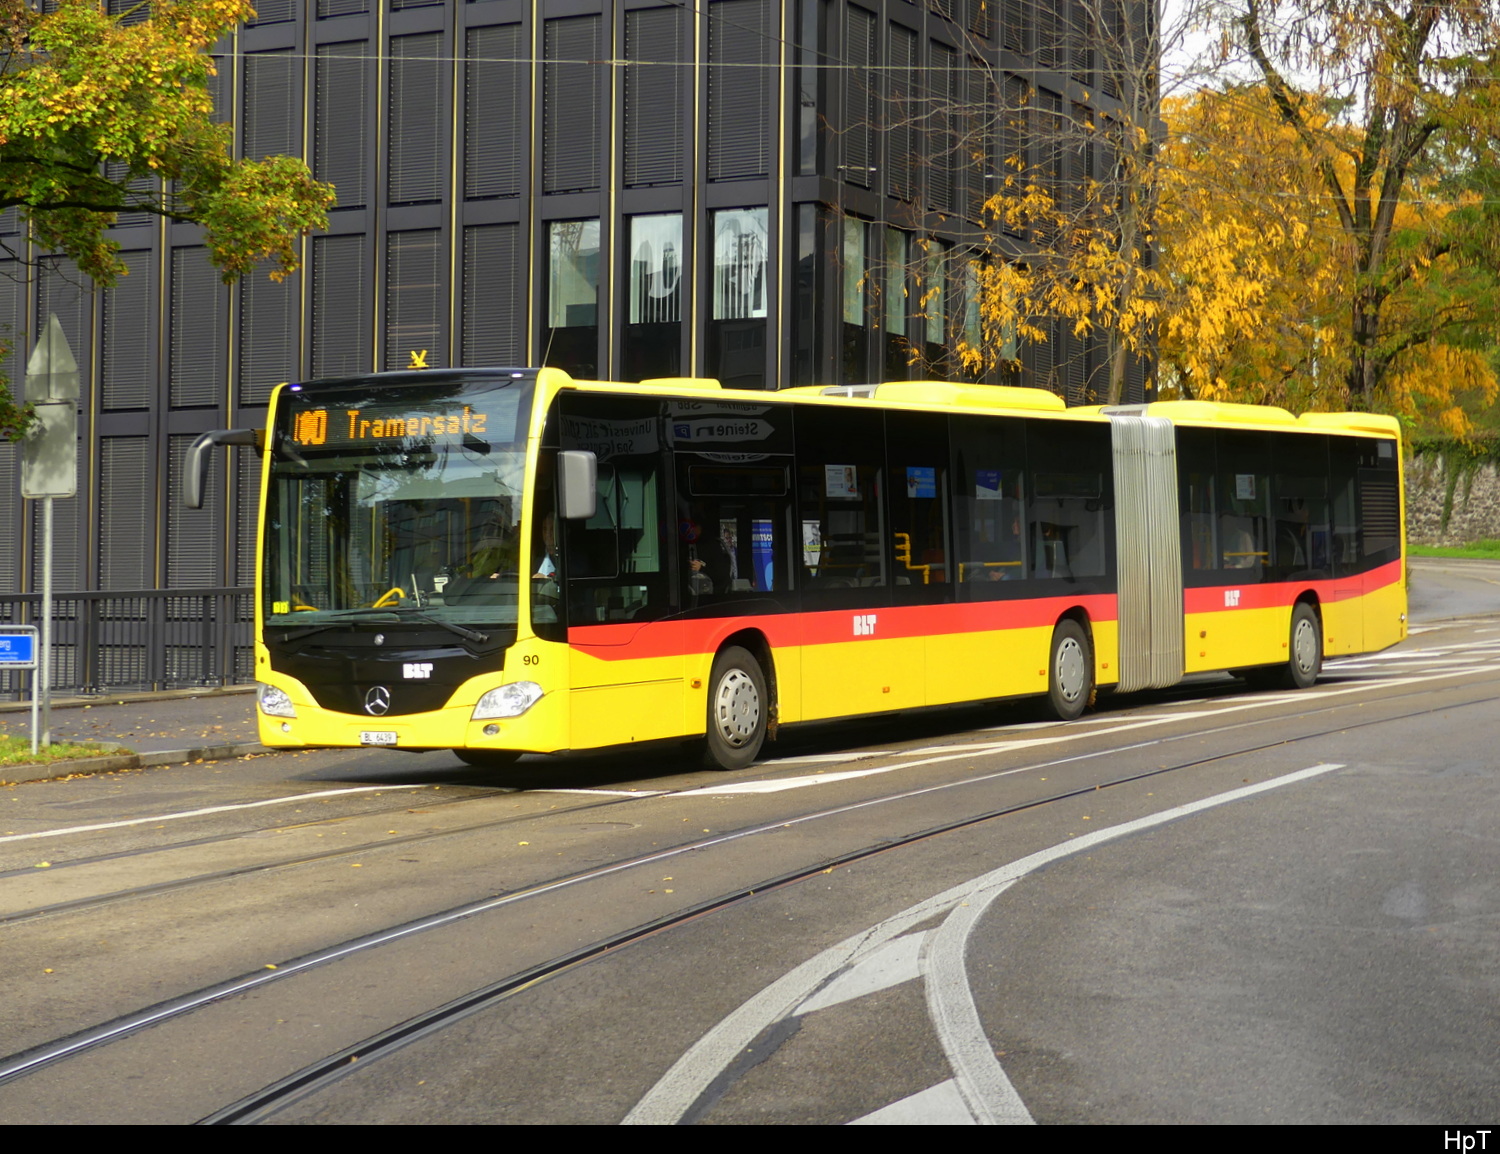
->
[621, 213, 683, 381]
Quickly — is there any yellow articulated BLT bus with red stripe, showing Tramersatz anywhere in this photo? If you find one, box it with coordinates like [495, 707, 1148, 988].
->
[188, 369, 1406, 768]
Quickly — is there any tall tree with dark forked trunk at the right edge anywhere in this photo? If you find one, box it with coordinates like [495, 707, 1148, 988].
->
[1229, 0, 1500, 410]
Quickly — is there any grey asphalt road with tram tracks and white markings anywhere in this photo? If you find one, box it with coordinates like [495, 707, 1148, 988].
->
[0, 566, 1500, 1125]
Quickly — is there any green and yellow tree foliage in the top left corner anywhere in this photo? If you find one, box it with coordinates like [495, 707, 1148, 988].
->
[0, 0, 335, 440]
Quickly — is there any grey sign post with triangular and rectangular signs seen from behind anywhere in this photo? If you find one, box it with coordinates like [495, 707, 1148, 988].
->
[21, 314, 78, 752]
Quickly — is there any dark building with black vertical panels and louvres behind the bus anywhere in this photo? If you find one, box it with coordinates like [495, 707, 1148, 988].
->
[0, 0, 1154, 684]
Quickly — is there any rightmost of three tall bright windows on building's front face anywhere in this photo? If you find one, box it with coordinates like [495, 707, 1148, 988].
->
[707, 209, 770, 389]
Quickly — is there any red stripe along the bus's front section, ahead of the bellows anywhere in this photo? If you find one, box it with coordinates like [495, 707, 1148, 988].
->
[569, 593, 1116, 660]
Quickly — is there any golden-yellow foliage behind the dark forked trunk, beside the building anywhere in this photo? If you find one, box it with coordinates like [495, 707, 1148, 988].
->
[1158, 83, 1500, 432]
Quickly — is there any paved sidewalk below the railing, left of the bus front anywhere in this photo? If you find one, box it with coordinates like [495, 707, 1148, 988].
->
[0, 686, 266, 782]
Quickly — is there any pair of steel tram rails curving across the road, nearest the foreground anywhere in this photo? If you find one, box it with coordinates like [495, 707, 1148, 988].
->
[0, 666, 1500, 1122]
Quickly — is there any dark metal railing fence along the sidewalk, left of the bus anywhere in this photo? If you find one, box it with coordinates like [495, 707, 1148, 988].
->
[0, 588, 255, 701]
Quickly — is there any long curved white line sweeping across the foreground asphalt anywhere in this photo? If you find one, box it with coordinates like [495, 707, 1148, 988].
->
[623, 764, 1343, 1125]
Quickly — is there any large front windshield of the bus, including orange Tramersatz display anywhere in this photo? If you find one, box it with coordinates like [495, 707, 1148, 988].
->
[263, 372, 534, 639]
